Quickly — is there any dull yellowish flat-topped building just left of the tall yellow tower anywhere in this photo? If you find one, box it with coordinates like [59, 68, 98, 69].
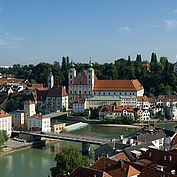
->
[10, 110, 25, 128]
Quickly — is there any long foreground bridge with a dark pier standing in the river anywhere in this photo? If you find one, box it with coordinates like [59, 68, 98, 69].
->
[13, 130, 110, 152]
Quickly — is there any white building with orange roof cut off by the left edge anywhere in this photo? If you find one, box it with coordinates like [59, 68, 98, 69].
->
[0, 110, 12, 136]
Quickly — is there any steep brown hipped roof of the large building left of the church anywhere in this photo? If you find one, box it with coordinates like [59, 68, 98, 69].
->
[47, 86, 68, 97]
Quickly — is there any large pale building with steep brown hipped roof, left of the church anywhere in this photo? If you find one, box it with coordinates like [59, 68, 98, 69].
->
[45, 86, 68, 113]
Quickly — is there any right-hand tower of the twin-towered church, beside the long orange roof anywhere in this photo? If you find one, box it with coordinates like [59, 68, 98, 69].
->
[87, 58, 95, 95]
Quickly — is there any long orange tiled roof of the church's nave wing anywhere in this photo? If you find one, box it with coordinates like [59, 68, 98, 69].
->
[93, 79, 143, 91]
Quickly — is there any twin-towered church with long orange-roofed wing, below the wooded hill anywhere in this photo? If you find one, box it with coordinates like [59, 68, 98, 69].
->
[68, 61, 144, 104]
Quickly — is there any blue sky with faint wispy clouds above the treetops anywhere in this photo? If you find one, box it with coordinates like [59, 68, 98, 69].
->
[0, 0, 177, 65]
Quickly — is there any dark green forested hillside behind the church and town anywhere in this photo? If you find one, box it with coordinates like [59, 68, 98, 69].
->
[0, 53, 177, 96]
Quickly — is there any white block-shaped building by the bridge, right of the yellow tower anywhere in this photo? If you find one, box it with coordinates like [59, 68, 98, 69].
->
[27, 114, 51, 132]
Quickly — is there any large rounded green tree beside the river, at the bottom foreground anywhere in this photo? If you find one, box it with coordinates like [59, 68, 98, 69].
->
[50, 147, 89, 177]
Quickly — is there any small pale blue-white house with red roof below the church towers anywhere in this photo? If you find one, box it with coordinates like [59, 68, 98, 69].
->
[73, 98, 86, 113]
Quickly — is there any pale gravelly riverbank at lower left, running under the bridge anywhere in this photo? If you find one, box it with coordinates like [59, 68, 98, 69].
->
[0, 139, 61, 157]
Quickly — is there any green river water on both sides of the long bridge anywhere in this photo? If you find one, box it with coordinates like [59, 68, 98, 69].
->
[0, 121, 174, 177]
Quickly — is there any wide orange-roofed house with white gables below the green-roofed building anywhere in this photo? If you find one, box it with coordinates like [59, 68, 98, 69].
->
[99, 106, 134, 120]
